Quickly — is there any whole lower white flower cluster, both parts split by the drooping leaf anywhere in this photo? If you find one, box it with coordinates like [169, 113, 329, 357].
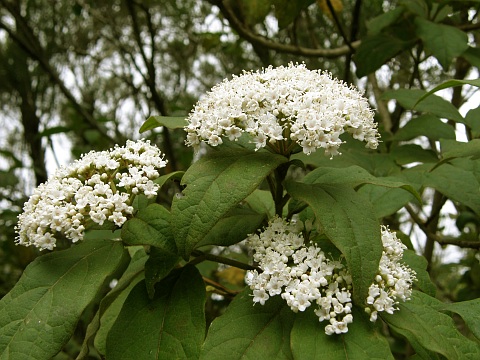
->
[245, 217, 415, 335]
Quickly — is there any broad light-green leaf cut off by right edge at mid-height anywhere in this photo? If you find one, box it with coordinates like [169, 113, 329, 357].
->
[424, 164, 480, 214]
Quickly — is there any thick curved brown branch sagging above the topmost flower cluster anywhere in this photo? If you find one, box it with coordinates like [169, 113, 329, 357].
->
[208, 0, 360, 58]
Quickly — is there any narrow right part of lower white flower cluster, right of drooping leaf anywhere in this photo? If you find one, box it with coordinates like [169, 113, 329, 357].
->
[365, 226, 416, 321]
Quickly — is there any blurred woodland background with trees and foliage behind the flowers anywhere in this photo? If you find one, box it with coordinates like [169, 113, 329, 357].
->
[0, 0, 480, 357]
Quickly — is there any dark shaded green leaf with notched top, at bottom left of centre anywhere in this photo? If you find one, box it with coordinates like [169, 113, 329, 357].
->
[106, 265, 205, 360]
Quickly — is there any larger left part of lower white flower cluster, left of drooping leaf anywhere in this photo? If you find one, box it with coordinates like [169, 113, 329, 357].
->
[246, 217, 353, 335]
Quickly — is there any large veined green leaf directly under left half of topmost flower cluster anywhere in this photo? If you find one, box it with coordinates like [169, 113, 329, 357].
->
[172, 149, 288, 258]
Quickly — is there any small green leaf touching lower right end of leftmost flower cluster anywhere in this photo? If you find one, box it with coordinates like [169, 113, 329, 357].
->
[122, 203, 177, 254]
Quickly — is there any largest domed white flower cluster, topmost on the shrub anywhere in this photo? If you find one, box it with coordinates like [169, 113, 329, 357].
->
[185, 63, 379, 156]
